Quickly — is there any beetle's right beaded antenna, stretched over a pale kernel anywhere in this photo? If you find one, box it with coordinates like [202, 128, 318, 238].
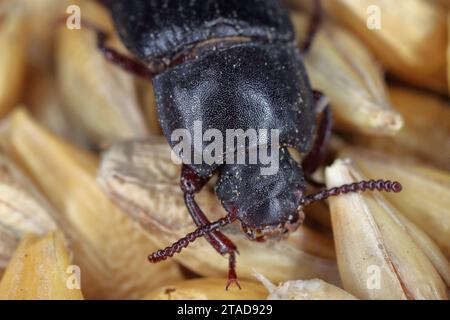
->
[302, 180, 402, 205]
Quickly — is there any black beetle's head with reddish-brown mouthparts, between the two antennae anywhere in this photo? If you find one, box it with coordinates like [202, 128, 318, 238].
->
[216, 148, 305, 241]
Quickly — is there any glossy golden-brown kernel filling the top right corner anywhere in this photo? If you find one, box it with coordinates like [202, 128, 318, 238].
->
[322, 0, 448, 93]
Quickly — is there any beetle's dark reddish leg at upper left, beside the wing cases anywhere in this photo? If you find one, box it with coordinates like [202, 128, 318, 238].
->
[82, 20, 164, 80]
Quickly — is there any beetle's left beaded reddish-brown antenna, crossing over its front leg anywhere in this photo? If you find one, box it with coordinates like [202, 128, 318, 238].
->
[148, 213, 237, 263]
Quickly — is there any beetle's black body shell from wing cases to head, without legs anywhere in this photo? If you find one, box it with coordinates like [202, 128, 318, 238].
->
[101, 0, 316, 235]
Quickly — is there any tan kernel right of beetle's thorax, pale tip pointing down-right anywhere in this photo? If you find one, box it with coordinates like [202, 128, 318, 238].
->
[292, 13, 403, 135]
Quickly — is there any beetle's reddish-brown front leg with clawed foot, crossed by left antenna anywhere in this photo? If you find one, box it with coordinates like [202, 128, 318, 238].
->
[180, 165, 240, 289]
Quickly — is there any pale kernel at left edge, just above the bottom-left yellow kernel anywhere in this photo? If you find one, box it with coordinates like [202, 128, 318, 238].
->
[0, 154, 56, 271]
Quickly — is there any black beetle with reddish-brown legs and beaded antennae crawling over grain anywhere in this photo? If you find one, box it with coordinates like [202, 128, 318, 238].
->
[86, 0, 402, 289]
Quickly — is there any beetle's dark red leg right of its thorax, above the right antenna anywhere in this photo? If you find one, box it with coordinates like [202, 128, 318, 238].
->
[302, 91, 333, 184]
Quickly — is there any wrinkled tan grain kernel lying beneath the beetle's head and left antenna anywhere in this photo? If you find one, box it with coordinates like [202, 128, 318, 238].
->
[98, 137, 337, 283]
